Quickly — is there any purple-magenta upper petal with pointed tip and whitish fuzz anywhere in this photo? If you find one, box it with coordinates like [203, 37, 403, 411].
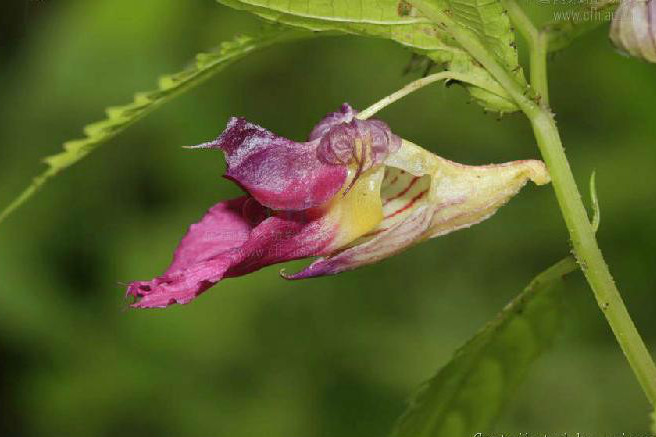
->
[213, 118, 347, 211]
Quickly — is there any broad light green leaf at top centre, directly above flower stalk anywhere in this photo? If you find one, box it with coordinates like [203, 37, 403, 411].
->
[218, 0, 525, 112]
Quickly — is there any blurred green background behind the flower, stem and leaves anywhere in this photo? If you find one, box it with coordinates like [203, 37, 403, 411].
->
[0, 0, 656, 437]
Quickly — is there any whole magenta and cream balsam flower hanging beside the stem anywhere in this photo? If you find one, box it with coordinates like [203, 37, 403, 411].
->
[127, 104, 549, 308]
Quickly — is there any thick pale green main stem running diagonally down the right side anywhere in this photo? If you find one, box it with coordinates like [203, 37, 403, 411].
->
[411, 0, 656, 406]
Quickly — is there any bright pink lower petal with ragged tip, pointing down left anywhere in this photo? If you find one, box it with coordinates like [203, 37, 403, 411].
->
[127, 197, 335, 308]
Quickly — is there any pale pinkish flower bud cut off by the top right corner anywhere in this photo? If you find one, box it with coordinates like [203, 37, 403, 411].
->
[610, 0, 656, 62]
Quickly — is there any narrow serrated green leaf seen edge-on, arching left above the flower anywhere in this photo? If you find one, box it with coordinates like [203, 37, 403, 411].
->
[0, 28, 312, 222]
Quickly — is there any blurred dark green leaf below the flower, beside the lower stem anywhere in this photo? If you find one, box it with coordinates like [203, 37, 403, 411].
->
[392, 257, 577, 437]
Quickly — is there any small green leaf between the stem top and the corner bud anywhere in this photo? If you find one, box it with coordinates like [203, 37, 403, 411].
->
[543, 0, 620, 52]
